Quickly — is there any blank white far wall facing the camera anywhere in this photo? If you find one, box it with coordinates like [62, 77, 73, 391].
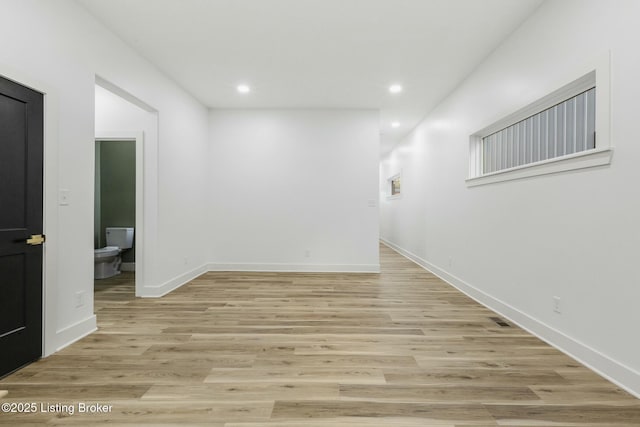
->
[207, 110, 379, 271]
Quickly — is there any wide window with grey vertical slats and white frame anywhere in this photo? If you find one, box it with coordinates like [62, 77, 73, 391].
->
[466, 67, 612, 186]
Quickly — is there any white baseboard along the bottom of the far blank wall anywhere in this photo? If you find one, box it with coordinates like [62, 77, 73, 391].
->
[209, 263, 380, 273]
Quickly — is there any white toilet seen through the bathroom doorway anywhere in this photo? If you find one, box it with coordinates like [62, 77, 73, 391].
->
[93, 227, 133, 279]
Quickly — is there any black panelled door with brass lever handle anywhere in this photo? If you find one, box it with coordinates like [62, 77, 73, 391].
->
[0, 77, 44, 376]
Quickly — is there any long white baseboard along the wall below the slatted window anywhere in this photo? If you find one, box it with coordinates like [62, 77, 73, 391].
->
[380, 238, 640, 399]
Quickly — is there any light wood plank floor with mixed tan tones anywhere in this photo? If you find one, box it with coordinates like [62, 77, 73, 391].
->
[0, 247, 640, 427]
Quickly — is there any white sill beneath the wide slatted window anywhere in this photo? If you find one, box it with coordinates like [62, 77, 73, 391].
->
[466, 147, 613, 187]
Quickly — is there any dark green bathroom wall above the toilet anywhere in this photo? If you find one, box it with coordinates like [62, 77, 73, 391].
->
[94, 141, 136, 262]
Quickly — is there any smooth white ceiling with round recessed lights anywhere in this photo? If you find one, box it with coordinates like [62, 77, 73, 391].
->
[77, 0, 542, 153]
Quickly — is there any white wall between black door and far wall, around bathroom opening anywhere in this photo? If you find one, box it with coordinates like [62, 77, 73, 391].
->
[0, 0, 207, 354]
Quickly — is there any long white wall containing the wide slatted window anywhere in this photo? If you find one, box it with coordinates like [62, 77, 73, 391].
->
[380, 0, 640, 395]
